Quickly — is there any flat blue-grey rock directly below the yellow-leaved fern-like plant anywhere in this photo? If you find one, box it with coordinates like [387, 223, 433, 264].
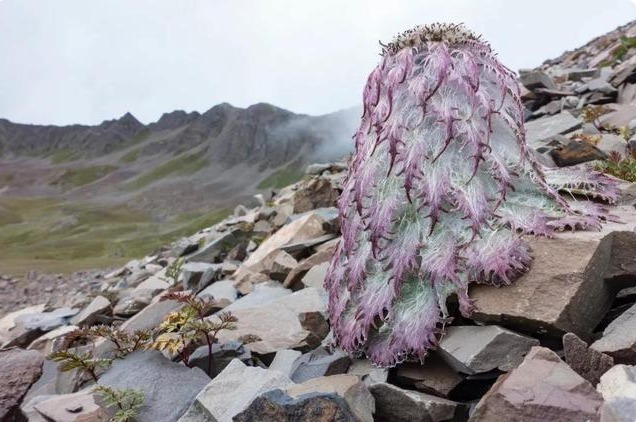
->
[99, 351, 210, 422]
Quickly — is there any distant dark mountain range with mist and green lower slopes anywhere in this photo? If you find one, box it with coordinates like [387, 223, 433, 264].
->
[0, 103, 359, 272]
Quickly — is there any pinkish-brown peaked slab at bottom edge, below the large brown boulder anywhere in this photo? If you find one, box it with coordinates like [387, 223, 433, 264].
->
[470, 347, 603, 422]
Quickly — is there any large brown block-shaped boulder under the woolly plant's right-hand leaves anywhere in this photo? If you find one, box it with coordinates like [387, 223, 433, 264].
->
[470, 227, 636, 339]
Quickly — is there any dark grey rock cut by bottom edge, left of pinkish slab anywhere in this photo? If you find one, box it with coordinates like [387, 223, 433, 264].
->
[369, 383, 465, 422]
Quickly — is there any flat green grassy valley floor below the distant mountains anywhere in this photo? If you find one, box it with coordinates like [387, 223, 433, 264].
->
[0, 197, 230, 274]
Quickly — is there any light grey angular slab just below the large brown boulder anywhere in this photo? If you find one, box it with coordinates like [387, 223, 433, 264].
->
[438, 325, 539, 375]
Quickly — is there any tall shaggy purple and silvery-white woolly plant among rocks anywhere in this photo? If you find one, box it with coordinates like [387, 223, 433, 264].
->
[325, 24, 618, 366]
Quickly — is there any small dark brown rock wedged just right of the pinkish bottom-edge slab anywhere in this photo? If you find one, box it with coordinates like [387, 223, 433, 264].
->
[563, 333, 614, 385]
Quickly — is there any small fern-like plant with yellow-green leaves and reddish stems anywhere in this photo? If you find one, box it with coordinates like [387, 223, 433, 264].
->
[148, 292, 260, 376]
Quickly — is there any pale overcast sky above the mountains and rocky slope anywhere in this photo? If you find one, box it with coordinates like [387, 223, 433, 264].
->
[0, 0, 636, 124]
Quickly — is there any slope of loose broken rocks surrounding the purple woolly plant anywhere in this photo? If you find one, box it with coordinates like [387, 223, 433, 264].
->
[0, 20, 636, 422]
